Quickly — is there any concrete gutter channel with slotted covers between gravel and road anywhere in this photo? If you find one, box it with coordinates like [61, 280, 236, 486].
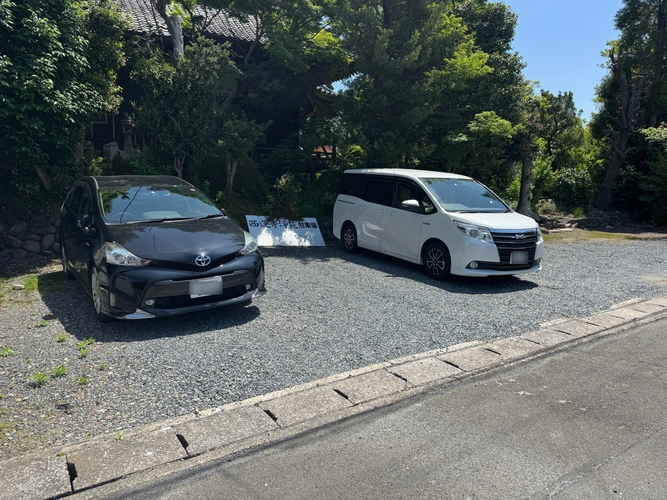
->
[0, 296, 667, 500]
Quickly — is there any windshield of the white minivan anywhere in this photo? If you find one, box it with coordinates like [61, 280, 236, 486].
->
[420, 177, 509, 214]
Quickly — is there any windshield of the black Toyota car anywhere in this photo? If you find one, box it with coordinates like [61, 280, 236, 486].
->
[100, 186, 224, 224]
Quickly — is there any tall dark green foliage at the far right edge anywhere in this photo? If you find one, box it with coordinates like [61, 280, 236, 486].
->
[591, 0, 667, 224]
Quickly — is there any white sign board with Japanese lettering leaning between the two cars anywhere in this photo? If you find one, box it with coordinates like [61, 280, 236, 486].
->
[245, 215, 325, 247]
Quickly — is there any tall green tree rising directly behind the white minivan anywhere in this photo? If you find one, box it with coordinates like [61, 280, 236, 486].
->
[325, 0, 491, 167]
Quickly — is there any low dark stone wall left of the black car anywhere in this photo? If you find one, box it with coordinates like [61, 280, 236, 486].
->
[0, 214, 60, 262]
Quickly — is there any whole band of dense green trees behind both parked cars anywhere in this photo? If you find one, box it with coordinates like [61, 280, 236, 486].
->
[0, 0, 667, 227]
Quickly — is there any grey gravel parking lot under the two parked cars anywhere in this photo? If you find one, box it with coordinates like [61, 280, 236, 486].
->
[0, 236, 667, 459]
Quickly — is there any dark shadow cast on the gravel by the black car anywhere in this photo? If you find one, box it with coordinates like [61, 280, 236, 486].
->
[37, 285, 260, 342]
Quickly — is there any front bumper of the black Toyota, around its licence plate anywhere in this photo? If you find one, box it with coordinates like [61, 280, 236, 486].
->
[100, 252, 266, 319]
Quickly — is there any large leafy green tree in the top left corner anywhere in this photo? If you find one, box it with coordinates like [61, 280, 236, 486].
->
[0, 0, 125, 190]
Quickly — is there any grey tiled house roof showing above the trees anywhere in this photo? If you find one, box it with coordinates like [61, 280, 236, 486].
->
[116, 0, 256, 41]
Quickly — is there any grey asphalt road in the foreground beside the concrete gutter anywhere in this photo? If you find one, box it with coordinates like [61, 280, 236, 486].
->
[105, 319, 667, 500]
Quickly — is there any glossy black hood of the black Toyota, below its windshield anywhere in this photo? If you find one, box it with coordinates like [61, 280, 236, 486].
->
[107, 218, 245, 262]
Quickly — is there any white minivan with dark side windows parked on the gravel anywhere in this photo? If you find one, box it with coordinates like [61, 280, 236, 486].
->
[333, 169, 544, 280]
